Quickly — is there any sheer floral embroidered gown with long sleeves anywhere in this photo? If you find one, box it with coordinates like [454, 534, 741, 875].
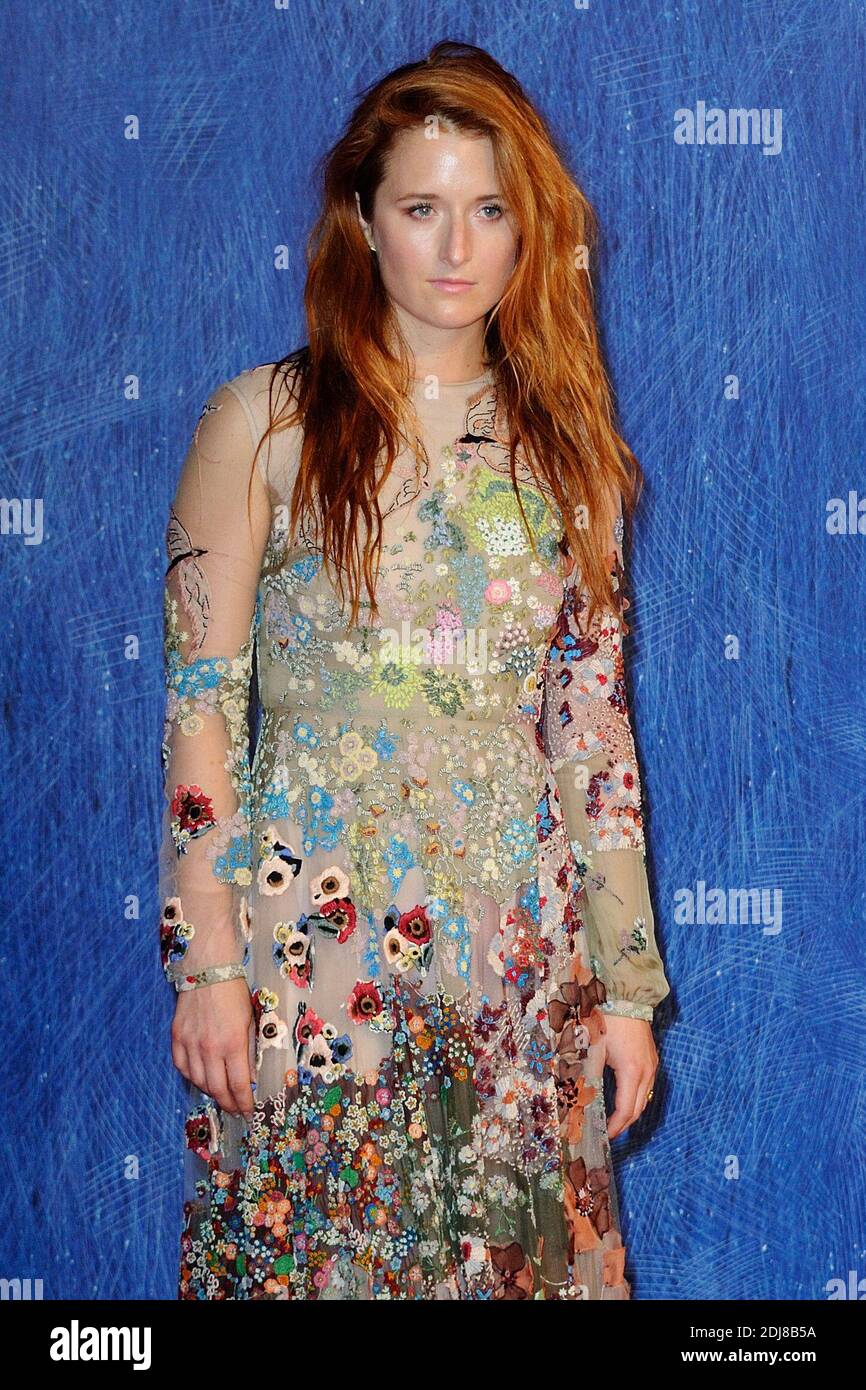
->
[160, 364, 669, 1300]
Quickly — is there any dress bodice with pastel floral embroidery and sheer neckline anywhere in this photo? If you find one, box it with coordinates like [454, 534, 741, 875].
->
[247, 375, 563, 897]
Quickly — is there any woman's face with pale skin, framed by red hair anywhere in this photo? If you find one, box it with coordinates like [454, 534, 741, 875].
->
[359, 126, 518, 346]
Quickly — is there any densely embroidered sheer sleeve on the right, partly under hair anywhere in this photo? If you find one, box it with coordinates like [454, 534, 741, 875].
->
[542, 500, 670, 1022]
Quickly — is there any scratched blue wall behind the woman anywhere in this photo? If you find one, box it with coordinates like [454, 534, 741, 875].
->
[0, 0, 866, 1300]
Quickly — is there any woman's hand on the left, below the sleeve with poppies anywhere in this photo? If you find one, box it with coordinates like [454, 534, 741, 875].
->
[171, 979, 254, 1123]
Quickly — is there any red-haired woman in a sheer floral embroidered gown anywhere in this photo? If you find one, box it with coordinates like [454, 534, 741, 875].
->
[161, 43, 669, 1300]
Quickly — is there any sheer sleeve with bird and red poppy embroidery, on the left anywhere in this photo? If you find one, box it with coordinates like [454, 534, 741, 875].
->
[160, 382, 271, 988]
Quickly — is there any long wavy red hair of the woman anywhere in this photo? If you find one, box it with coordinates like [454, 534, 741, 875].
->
[247, 42, 642, 632]
